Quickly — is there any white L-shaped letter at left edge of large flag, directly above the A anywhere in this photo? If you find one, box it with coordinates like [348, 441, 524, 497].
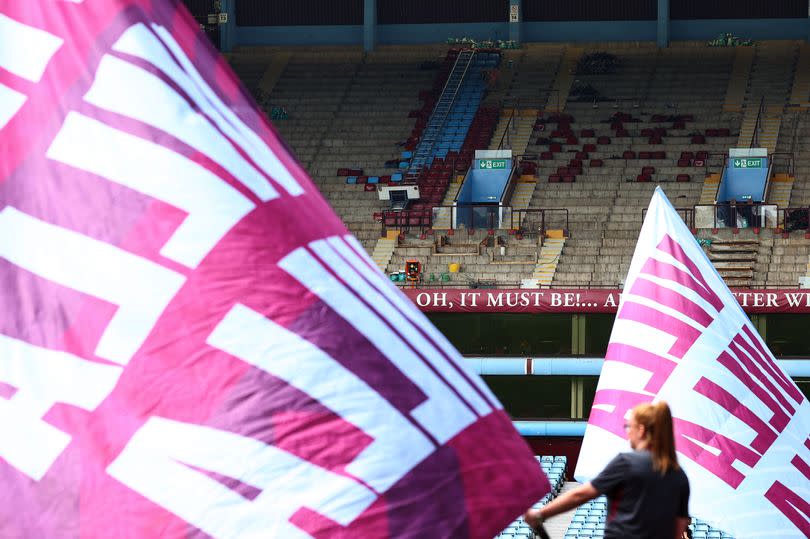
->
[0, 206, 185, 365]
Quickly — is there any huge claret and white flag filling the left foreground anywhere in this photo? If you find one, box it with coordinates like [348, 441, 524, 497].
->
[0, 0, 549, 539]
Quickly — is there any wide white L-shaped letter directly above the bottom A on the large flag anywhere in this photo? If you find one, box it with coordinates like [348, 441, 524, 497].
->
[208, 305, 435, 495]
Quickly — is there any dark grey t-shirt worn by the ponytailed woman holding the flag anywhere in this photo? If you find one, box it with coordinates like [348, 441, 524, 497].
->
[591, 451, 689, 539]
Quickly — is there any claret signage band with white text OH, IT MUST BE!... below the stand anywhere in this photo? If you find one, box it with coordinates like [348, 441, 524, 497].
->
[403, 289, 810, 314]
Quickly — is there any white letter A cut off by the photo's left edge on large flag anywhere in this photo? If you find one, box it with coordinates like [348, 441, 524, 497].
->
[0, 334, 122, 481]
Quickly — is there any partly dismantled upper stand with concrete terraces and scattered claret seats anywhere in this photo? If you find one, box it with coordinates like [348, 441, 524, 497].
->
[248, 42, 810, 287]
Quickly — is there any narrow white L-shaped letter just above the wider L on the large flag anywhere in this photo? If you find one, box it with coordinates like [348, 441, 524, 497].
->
[278, 239, 475, 444]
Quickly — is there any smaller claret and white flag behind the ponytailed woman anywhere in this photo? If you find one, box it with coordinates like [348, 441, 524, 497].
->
[575, 187, 810, 539]
